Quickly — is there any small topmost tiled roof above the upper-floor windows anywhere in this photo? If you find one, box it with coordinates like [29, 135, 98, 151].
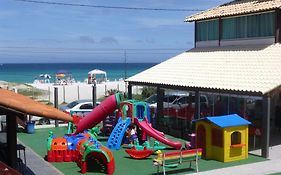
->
[185, 0, 281, 22]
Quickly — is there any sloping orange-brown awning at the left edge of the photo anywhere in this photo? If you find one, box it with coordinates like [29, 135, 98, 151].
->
[0, 89, 72, 122]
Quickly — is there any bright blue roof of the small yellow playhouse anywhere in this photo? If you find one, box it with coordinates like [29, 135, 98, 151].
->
[200, 114, 251, 128]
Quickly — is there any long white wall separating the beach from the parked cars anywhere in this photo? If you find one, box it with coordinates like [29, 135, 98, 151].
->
[0, 80, 142, 105]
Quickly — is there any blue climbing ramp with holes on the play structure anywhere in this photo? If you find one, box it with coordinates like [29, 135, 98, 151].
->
[106, 118, 131, 150]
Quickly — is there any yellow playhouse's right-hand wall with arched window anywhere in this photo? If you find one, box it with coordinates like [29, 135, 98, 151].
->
[223, 126, 248, 162]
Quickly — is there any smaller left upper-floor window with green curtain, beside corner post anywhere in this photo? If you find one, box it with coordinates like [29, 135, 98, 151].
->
[196, 19, 219, 41]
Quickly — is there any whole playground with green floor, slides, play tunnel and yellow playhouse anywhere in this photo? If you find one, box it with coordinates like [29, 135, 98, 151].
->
[12, 93, 266, 175]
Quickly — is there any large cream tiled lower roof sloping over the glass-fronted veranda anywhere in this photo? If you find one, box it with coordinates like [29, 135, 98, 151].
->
[127, 44, 281, 94]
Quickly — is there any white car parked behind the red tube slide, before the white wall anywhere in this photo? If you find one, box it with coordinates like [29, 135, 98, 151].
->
[59, 100, 100, 114]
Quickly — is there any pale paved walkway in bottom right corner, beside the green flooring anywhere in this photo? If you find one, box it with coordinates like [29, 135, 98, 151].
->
[188, 145, 281, 175]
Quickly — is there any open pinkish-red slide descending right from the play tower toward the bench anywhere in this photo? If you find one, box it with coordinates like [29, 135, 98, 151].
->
[134, 118, 182, 150]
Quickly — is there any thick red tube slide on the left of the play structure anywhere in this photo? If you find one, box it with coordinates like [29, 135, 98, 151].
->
[74, 93, 121, 134]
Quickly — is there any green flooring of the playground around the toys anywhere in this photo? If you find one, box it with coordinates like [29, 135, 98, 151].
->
[18, 127, 266, 175]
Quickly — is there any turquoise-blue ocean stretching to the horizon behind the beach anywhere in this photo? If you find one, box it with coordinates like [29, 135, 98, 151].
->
[0, 63, 157, 83]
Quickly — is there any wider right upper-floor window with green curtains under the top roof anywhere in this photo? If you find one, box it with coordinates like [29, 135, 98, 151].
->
[222, 13, 275, 39]
